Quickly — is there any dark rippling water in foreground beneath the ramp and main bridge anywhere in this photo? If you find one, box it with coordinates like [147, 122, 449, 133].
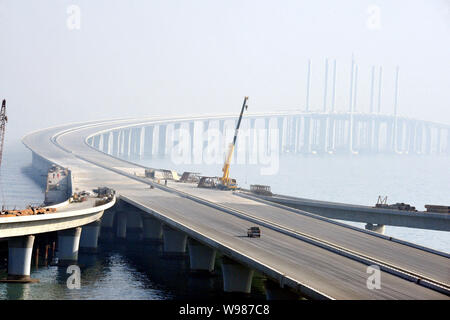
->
[0, 242, 265, 300]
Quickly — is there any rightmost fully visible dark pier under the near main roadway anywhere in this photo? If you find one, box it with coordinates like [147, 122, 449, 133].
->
[222, 257, 253, 293]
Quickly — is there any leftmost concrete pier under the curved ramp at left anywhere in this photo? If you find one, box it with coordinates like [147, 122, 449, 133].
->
[7, 236, 34, 282]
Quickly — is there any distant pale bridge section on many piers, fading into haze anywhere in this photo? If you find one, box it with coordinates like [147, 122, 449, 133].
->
[88, 111, 450, 161]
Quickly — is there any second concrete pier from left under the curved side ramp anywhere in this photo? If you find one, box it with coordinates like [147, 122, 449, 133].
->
[58, 227, 81, 265]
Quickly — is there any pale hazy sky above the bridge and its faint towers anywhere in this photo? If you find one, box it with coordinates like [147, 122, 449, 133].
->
[0, 0, 450, 143]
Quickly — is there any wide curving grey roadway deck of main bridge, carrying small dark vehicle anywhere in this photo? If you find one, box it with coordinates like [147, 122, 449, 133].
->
[19, 115, 450, 299]
